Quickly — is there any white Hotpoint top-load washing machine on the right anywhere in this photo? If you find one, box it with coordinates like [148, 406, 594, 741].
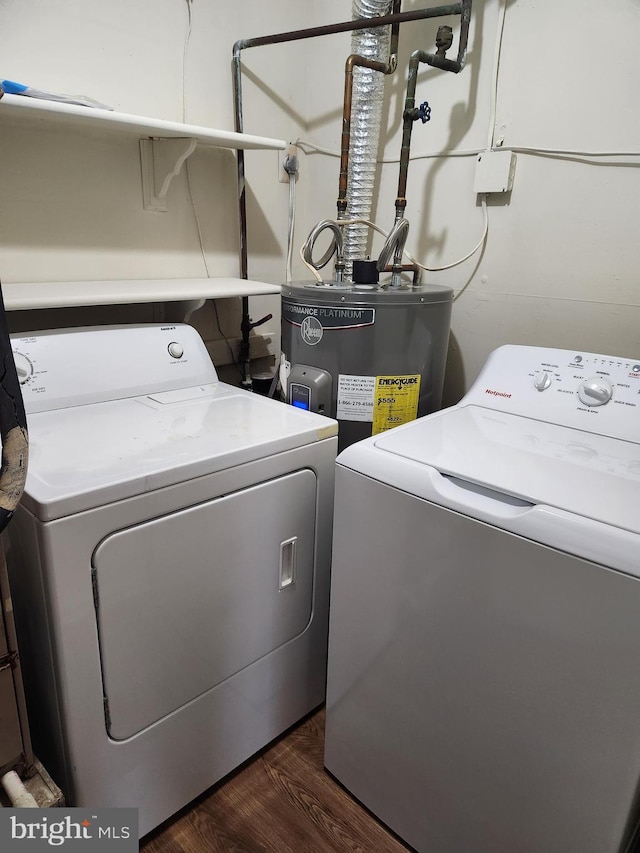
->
[325, 346, 640, 853]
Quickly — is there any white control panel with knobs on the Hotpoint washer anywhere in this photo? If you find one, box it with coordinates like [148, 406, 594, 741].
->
[460, 345, 640, 443]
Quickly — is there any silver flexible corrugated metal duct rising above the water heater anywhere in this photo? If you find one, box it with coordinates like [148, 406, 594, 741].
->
[344, 0, 392, 280]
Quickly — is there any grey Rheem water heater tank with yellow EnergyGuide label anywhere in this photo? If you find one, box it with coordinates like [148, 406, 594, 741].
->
[282, 282, 453, 449]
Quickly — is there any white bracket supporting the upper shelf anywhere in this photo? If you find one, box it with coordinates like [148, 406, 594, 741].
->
[140, 137, 198, 213]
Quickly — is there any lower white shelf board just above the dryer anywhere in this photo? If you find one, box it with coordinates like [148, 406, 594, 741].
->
[2, 278, 280, 311]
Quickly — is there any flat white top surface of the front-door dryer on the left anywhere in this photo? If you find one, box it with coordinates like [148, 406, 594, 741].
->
[22, 383, 338, 521]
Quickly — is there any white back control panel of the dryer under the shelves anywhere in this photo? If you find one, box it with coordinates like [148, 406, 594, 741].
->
[11, 323, 218, 414]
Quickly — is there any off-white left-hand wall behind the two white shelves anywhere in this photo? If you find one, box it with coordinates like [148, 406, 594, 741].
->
[0, 0, 306, 372]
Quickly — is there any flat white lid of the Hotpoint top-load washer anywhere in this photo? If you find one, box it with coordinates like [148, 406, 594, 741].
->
[348, 406, 640, 533]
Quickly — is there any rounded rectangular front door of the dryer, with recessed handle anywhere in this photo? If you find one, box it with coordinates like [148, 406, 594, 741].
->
[93, 470, 316, 740]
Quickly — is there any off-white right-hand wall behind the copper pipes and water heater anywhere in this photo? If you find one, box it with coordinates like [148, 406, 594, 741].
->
[301, 0, 640, 402]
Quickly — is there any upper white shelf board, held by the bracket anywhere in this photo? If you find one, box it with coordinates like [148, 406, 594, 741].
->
[0, 95, 287, 149]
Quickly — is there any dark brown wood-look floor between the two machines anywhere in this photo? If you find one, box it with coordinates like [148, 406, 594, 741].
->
[140, 710, 409, 853]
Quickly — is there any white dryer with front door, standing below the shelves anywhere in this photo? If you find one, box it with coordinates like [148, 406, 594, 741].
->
[7, 325, 337, 834]
